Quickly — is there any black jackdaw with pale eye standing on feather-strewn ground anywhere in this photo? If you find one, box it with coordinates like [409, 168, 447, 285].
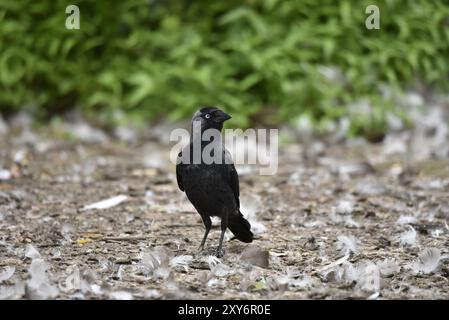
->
[176, 107, 253, 257]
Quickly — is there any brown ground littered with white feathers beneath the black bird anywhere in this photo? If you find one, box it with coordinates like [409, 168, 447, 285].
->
[0, 117, 449, 299]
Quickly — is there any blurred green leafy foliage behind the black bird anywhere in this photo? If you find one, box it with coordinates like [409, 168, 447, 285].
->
[0, 0, 449, 134]
